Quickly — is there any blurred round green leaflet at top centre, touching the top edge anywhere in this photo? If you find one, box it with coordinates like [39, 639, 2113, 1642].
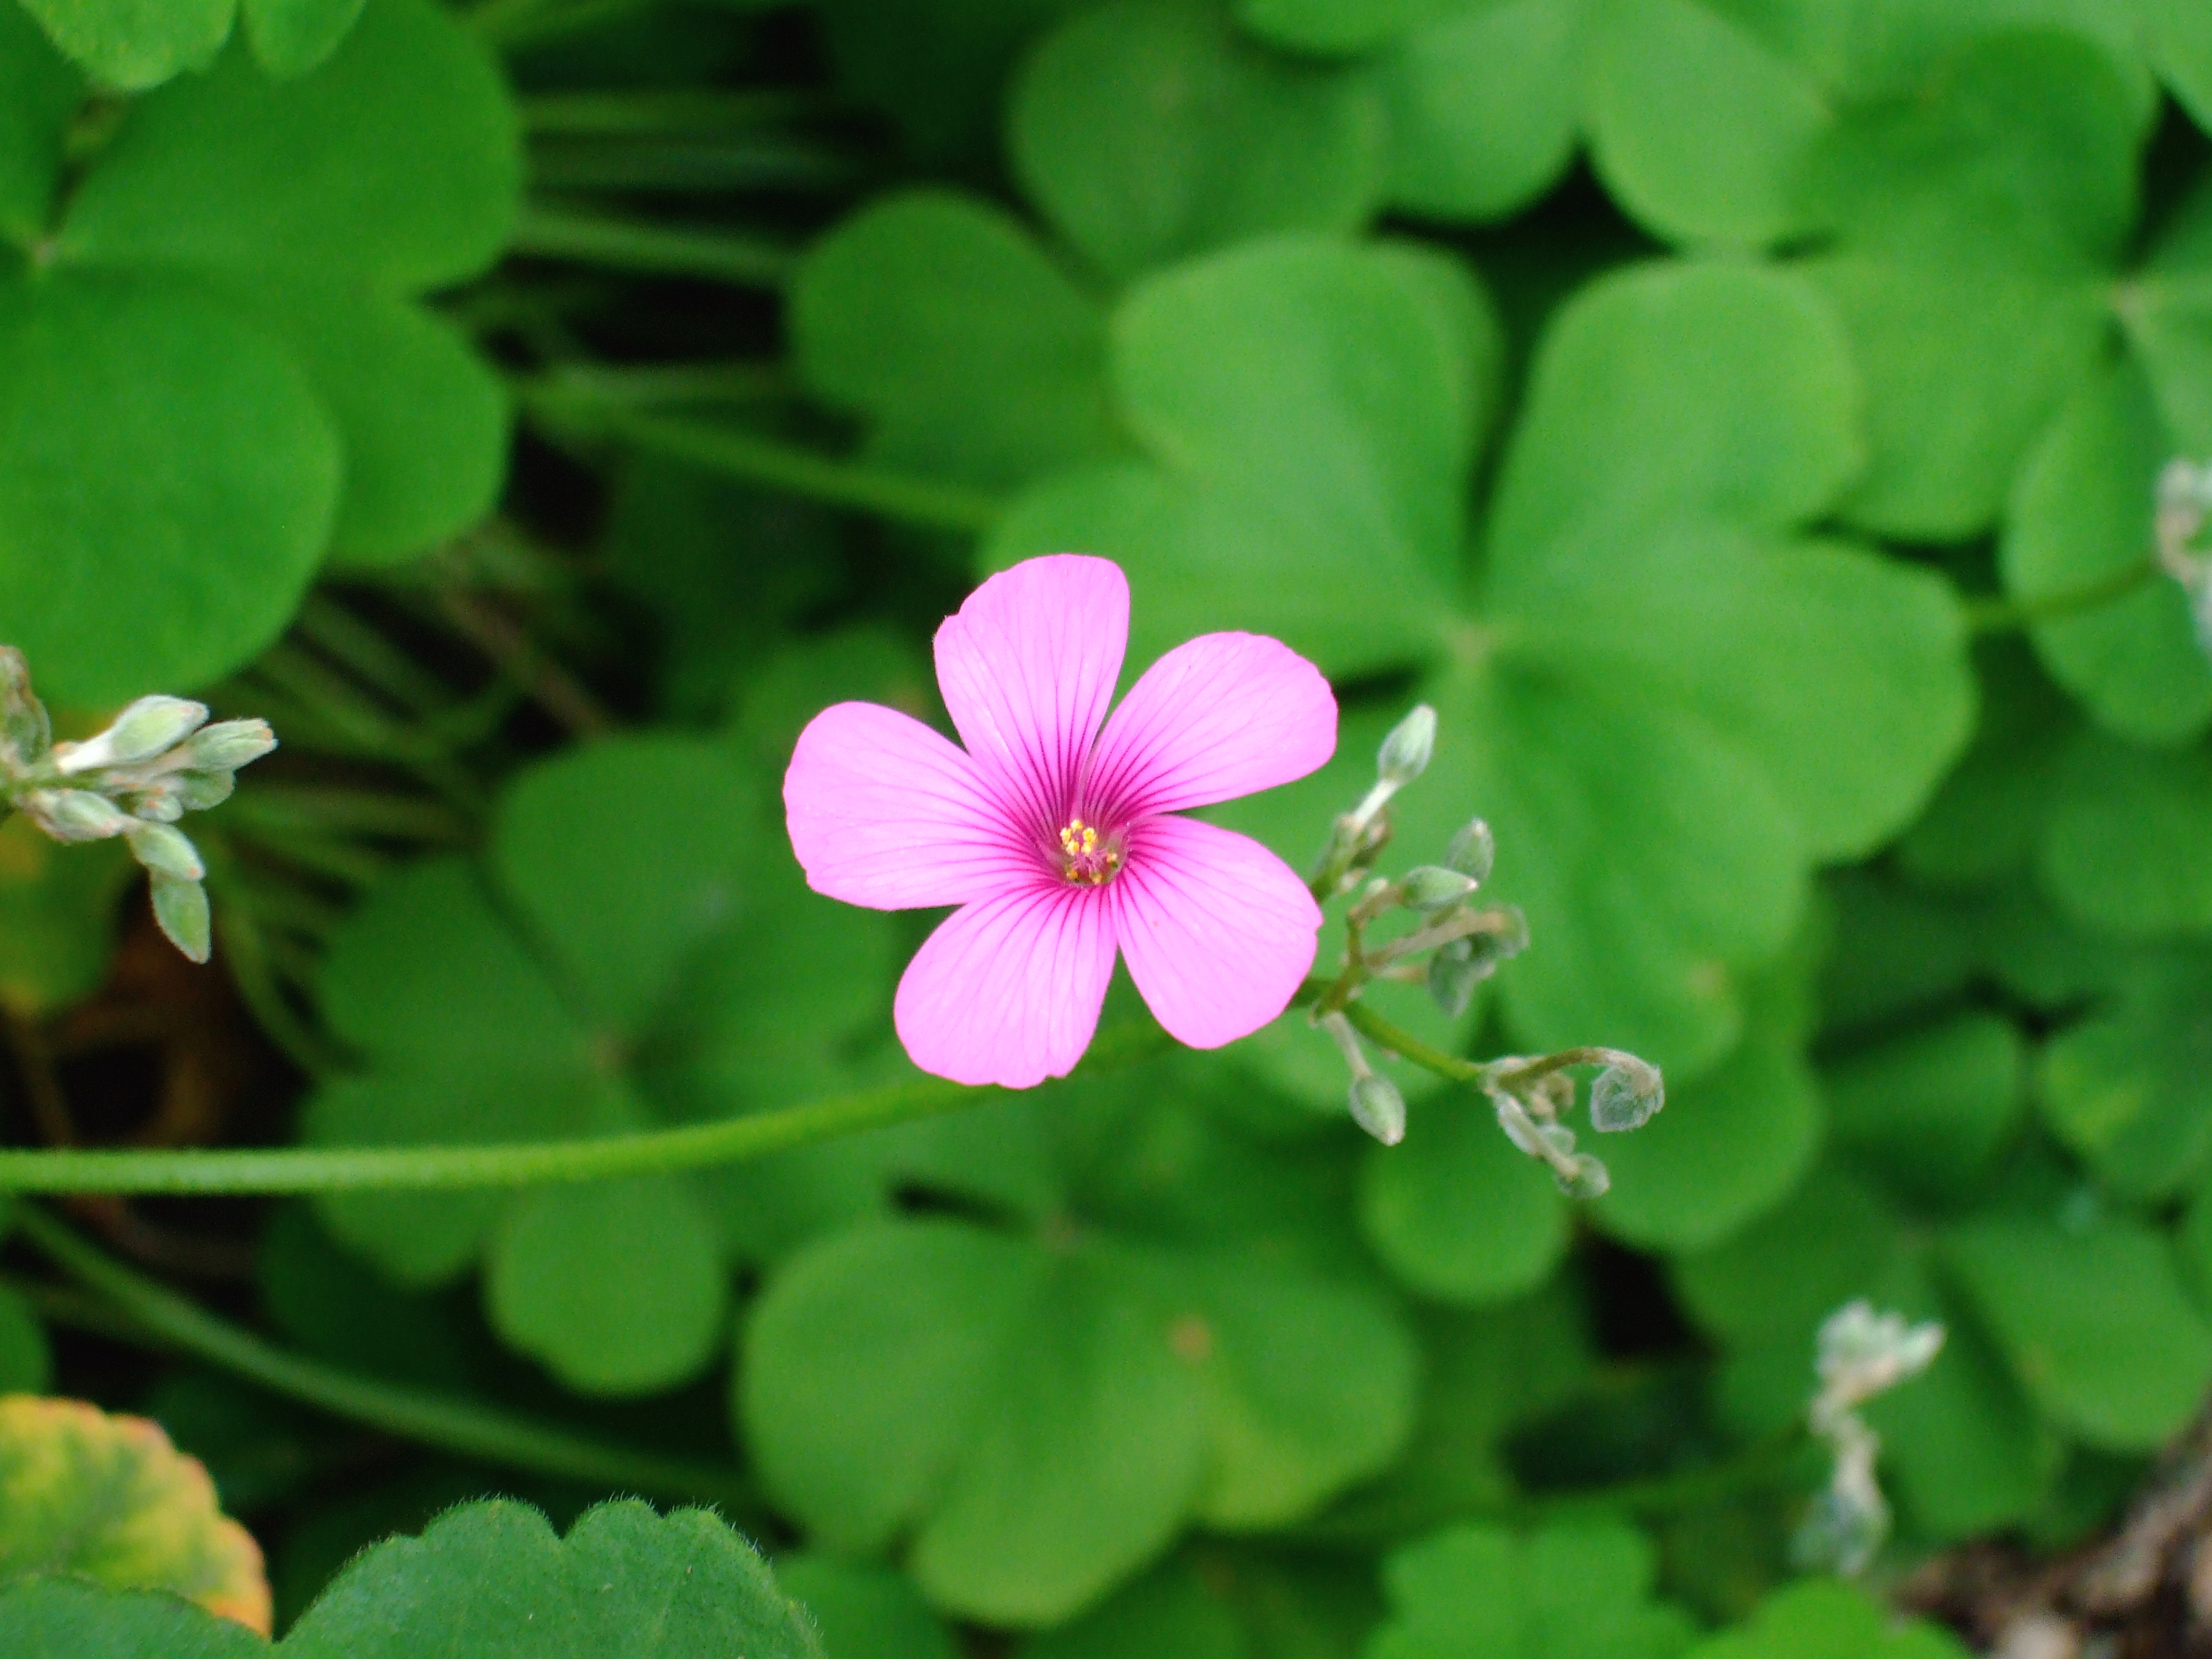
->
[1009, 0, 1382, 279]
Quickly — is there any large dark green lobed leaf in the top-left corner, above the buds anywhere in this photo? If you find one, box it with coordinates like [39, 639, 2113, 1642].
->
[0, 0, 520, 706]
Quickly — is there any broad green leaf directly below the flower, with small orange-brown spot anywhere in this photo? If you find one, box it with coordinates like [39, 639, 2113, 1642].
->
[736, 1059, 1414, 1626]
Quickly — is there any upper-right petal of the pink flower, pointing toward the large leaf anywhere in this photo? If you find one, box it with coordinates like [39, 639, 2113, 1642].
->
[1084, 633, 1336, 816]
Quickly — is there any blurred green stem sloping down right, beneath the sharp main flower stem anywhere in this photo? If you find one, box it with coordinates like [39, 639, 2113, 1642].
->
[13, 1205, 756, 1508]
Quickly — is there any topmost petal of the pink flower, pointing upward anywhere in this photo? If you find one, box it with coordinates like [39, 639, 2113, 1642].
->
[938, 553, 1128, 830]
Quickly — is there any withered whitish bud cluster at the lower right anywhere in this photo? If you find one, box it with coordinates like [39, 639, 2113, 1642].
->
[1794, 1301, 1944, 1577]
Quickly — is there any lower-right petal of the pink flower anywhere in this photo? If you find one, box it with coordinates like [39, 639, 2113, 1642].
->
[1099, 819, 1320, 1049]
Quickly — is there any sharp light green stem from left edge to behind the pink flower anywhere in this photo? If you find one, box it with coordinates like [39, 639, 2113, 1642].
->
[0, 1026, 1168, 1195]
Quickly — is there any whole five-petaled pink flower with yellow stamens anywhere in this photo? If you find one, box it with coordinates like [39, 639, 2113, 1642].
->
[783, 553, 1336, 1088]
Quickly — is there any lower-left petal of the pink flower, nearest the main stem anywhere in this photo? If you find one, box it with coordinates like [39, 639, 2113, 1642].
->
[892, 881, 1113, 1088]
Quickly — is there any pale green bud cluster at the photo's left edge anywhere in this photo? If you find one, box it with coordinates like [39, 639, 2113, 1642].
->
[0, 646, 276, 962]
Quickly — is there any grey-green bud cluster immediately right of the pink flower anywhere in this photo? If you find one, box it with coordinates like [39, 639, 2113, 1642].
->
[1312, 706, 1666, 1199]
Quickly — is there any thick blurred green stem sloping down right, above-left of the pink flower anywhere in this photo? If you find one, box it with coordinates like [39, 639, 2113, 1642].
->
[517, 393, 1002, 535]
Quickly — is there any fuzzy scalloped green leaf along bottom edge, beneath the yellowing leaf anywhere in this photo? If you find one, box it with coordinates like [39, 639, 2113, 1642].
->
[0, 1502, 821, 1659]
